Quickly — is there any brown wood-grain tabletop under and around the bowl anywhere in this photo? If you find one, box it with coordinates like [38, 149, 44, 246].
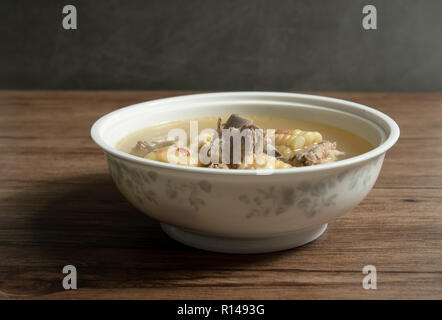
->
[0, 91, 442, 299]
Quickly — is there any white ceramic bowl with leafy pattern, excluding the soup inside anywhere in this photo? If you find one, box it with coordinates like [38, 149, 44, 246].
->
[91, 92, 399, 253]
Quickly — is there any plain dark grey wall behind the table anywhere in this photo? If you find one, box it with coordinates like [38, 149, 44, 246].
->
[0, 0, 442, 91]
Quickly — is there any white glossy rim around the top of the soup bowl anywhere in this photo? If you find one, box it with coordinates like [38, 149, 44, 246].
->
[90, 91, 400, 176]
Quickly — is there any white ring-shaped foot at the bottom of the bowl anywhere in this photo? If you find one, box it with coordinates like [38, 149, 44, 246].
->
[161, 223, 327, 253]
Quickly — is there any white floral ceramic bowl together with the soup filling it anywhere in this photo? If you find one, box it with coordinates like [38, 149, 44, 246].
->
[91, 92, 399, 253]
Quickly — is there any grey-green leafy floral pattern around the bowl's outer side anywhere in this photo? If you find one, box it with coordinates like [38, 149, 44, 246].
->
[108, 157, 382, 219]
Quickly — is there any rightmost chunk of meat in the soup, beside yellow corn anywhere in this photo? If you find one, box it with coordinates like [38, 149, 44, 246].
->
[289, 140, 344, 167]
